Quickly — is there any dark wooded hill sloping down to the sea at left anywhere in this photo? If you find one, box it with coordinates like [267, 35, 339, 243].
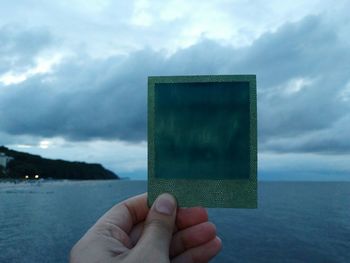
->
[0, 146, 119, 180]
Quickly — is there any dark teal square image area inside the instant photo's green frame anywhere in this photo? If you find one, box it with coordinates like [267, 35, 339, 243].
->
[155, 82, 250, 182]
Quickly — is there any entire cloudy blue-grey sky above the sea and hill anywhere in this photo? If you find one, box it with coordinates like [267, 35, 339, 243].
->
[0, 0, 350, 180]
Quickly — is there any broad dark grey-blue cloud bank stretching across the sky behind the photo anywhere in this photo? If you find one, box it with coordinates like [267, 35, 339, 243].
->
[0, 14, 350, 153]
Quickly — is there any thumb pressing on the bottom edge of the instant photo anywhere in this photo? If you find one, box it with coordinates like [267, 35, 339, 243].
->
[138, 193, 177, 258]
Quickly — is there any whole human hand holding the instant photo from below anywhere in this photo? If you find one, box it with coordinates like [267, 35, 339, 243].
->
[70, 194, 221, 263]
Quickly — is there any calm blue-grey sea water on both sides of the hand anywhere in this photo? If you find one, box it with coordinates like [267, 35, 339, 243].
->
[0, 181, 350, 263]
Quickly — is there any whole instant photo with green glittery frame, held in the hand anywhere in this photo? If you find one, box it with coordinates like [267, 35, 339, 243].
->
[148, 75, 257, 208]
